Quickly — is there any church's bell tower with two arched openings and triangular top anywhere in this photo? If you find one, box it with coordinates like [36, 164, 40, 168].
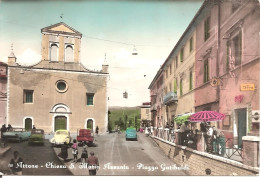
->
[41, 22, 82, 63]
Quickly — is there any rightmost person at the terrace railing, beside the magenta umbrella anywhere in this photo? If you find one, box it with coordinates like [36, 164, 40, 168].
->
[212, 126, 226, 156]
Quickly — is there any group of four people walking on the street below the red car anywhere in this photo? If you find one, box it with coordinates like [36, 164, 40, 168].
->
[58, 139, 99, 175]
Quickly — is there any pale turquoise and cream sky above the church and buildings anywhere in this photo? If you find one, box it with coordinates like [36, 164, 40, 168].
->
[0, 0, 203, 106]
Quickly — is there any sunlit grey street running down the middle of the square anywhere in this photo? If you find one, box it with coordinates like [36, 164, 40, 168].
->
[52, 133, 186, 176]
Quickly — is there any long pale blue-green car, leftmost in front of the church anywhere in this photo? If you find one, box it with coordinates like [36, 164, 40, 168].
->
[3, 128, 31, 142]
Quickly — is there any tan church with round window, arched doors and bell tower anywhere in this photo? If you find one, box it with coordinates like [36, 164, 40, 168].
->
[7, 22, 108, 133]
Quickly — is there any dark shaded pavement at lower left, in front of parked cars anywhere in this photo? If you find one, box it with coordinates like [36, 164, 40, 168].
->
[0, 140, 72, 175]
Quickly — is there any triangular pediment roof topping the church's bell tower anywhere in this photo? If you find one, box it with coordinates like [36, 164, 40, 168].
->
[41, 22, 82, 37]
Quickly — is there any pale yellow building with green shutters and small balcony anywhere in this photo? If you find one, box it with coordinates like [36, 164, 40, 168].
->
[162, 25, 196, 128]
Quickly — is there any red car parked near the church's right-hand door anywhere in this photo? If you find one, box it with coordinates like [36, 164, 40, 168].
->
[77, 129, 94, 146]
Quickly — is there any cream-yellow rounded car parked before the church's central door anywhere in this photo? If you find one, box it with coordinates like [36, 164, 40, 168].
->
[50, 130, 71, 146]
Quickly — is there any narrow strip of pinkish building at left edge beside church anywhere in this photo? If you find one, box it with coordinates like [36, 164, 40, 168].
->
[0, 62, 7, 126]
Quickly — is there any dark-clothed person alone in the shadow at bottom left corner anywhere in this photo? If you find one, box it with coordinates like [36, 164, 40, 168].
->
[9, 151, 24, 175]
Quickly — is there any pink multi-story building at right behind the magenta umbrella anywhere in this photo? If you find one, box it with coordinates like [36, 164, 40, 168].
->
[195, 1, 260, 147]
